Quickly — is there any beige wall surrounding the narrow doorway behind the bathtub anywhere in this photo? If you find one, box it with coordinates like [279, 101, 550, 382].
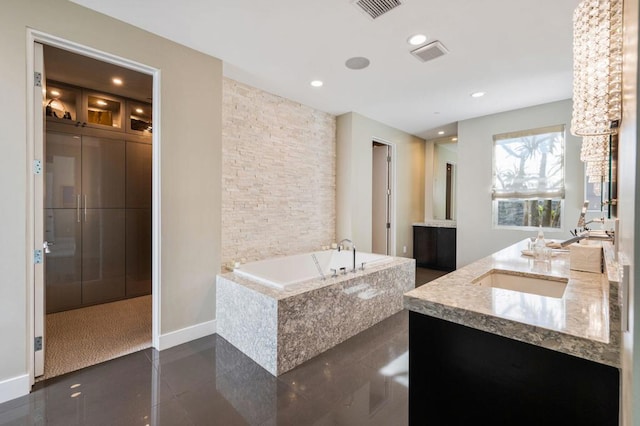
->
[336, 112, 425, 257]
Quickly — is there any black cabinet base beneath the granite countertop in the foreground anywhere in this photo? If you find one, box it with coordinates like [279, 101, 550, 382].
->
[409, 312, 620, 426]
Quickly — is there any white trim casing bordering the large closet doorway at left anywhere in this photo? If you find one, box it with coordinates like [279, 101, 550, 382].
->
[26, 28, 162, 385]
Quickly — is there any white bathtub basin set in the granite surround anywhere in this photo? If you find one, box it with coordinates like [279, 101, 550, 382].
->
[233, 250, 393, 289]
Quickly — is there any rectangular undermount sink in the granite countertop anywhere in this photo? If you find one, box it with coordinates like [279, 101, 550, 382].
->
[472, 270, 568, 298]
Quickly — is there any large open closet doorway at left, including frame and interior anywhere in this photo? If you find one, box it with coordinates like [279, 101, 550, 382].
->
[30, 32, 159, 381]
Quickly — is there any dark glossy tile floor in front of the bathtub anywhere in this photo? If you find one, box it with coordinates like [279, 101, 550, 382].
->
[0, 268, 450, 426]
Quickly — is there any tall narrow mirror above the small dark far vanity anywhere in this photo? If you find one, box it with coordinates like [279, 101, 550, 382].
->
[433, 139, 458, 220]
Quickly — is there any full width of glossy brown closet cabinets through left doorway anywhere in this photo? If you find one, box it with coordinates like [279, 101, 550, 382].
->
[44, 80, 152, 313]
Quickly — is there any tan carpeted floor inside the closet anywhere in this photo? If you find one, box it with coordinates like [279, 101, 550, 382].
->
[39, 296, 151, 380]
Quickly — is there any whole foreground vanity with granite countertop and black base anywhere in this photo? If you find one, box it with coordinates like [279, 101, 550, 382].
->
[404, 241, 622, 426]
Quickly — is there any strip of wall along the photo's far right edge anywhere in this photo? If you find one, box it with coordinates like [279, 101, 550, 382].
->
[618, 0, 640, 425]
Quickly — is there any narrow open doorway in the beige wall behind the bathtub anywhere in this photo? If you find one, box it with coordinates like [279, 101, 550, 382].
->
[371, 141, 393, 255]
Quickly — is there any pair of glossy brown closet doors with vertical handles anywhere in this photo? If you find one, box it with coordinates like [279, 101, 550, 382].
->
[45, 132, 125, 312]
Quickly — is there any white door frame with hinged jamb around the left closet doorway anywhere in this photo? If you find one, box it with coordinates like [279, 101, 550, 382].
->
[25, 28, 161, 385]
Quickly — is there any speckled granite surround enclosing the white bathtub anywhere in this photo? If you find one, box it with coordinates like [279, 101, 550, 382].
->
[216, 258, 415, 376]
